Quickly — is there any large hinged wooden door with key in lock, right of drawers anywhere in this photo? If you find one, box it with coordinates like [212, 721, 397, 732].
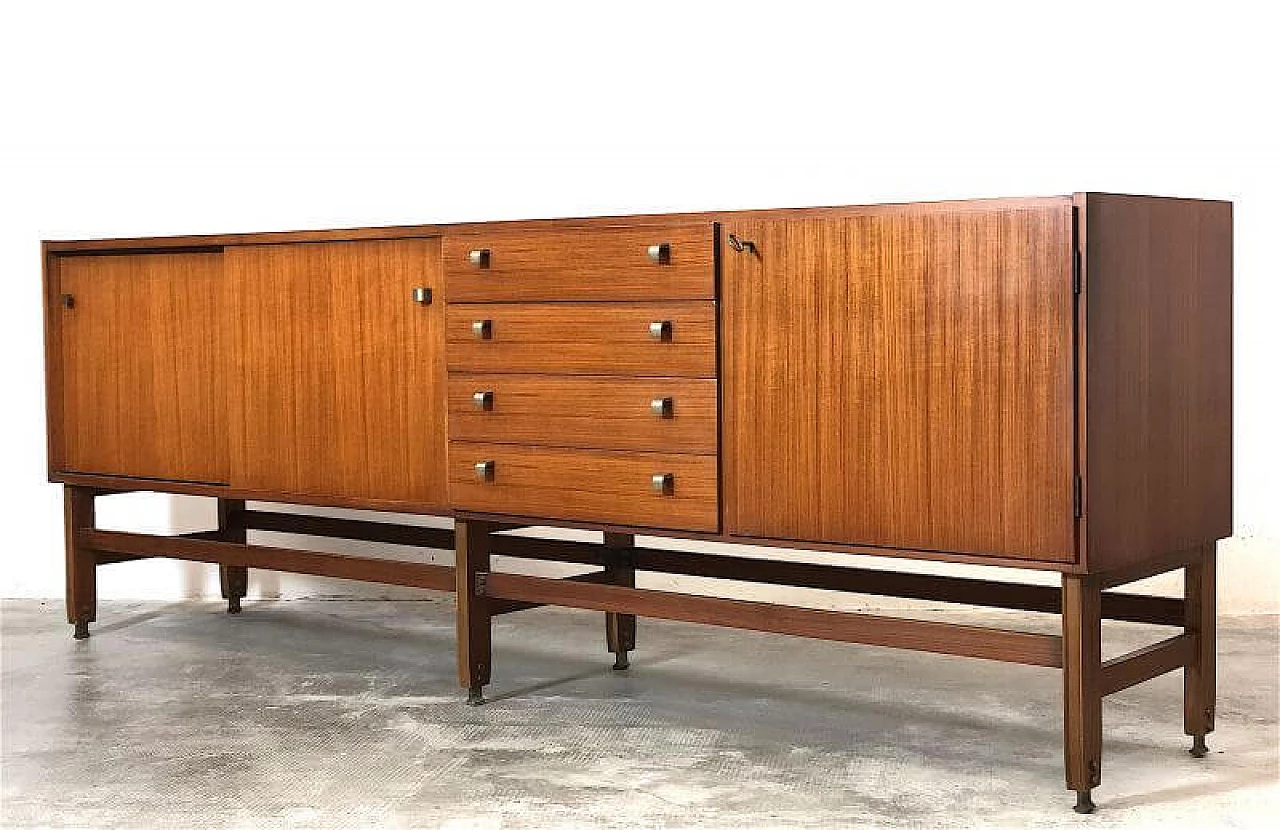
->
[722, 206, 1074, 561]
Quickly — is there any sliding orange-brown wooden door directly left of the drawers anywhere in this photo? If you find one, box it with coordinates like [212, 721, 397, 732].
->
[227, 240, 445, 506]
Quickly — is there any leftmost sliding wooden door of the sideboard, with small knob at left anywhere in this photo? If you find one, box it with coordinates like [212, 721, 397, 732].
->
[57, 252, 229, 483]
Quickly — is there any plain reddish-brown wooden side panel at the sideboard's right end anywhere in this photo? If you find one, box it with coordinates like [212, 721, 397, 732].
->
[1084, 193, 1231, 570]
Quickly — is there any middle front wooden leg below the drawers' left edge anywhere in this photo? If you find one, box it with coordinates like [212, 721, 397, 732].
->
[453, 519, 494, 706]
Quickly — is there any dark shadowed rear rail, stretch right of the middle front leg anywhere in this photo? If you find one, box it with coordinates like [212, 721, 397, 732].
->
[492, 535, 1183, 626]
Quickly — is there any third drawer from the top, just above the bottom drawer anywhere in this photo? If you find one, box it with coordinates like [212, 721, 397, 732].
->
[449, 374, 717, 455]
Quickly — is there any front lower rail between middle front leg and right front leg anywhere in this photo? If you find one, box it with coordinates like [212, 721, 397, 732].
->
[484, 573, 1062, 669]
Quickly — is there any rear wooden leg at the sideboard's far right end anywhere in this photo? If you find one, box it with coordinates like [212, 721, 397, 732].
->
[1183, 544, 1217, 758]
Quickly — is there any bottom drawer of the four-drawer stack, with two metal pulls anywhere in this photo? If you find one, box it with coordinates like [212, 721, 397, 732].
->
[449, 441, 719, 532]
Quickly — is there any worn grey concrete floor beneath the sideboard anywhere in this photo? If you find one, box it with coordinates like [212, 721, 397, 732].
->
[0, 598, 1280, 830]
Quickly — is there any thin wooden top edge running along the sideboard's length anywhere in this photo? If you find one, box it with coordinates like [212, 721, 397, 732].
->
[44, 193, 1220, 254]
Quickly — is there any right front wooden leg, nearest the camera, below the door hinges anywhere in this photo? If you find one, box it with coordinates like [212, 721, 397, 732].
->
[1062, 574, 1102, 812]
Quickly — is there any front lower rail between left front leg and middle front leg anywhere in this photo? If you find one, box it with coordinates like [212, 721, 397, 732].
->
[79, 530, 454, 590]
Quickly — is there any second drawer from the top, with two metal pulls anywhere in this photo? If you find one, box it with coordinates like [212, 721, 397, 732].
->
[445, 302, 716, 378]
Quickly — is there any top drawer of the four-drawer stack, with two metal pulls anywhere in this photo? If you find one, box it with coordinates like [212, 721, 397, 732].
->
[443, 223, 716, 302]
